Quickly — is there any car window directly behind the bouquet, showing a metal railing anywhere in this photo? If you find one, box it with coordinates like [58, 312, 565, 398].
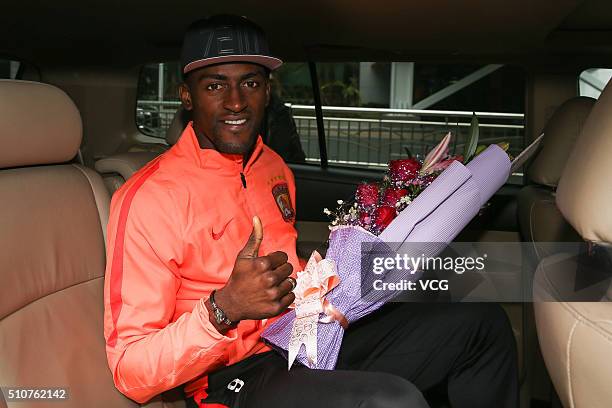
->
[311, 62, 526, 174]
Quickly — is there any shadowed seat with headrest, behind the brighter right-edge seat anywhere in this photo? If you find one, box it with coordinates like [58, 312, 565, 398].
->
[517, 96, 595, 266]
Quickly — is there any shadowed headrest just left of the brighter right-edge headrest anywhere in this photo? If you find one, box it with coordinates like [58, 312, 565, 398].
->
[529, 96, 596, 187]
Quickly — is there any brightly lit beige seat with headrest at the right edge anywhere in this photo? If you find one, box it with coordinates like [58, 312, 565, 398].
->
[534, 85, 612, 408]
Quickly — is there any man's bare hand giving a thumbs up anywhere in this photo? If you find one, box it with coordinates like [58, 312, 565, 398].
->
[215, 216, 295, 322]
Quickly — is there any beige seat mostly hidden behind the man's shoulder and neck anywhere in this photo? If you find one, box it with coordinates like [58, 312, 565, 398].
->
[95, 107, 190, 195]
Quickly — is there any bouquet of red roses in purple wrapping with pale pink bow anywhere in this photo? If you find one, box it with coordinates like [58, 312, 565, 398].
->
[262, 121, 511, 369]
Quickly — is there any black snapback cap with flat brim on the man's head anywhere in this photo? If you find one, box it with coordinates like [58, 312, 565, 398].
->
[181, 15, 283, 74]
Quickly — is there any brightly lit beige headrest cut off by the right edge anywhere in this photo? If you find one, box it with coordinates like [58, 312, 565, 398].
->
[556, 83, 612, 243]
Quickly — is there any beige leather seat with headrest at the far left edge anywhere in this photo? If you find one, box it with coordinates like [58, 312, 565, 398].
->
[0, 80, 185, 408]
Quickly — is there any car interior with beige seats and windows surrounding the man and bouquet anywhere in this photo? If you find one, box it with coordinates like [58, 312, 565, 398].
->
[0, 0, 612, 408]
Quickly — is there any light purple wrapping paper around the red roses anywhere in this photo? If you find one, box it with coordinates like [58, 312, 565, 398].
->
[262, 145, 510, 370]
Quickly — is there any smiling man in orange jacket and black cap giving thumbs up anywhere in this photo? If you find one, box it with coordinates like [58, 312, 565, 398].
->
[104, 16, 517, 408]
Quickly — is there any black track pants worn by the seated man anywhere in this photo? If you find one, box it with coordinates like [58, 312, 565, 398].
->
[190, 303, 518, 408]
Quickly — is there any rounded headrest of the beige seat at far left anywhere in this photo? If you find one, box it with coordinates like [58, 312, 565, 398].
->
[0, 80, 83, 168]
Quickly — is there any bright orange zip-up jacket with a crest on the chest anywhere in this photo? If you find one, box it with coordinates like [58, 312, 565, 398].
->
[104, 123, 299, 402]
